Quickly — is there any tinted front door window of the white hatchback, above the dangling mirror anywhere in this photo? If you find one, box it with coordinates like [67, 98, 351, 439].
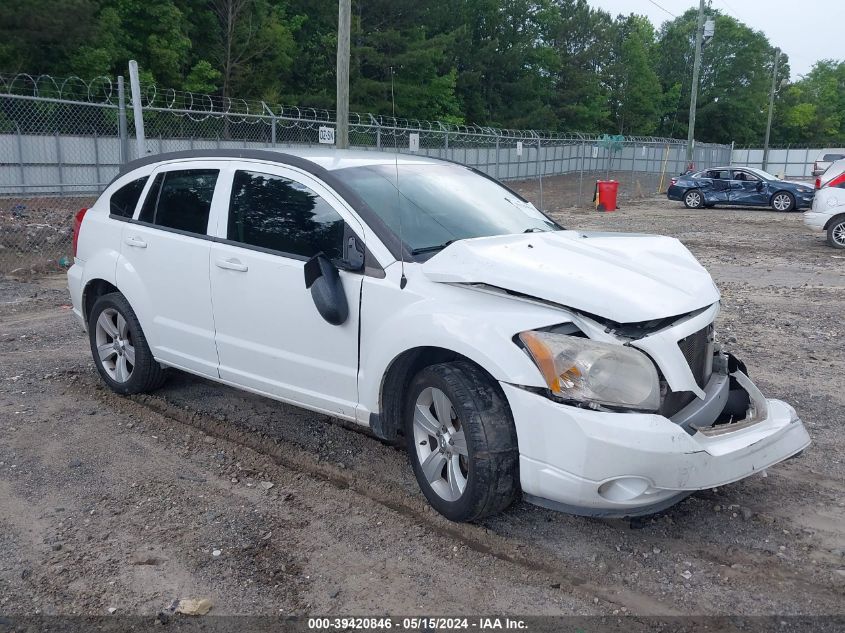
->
[226, 171, 344, 259]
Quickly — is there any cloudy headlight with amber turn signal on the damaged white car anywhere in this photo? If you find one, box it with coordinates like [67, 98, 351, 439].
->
[519, 332, 660, 411]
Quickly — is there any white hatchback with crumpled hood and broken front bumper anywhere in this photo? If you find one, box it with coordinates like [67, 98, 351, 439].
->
[68, 149, 810, 521]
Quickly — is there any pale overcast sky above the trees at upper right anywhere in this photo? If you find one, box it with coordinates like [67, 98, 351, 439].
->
[587, 0, 845, 80]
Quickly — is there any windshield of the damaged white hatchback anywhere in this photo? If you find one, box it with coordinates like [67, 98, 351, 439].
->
[333, 164, 561, 254]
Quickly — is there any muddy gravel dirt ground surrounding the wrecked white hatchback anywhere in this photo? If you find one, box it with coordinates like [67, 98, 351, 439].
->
[0, 189, 845, 616]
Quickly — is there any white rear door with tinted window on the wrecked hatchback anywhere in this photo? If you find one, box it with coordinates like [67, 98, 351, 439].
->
[117, 161, 226, 378]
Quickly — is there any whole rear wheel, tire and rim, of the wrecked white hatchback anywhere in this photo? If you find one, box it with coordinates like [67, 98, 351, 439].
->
[88, 292, 166, 395]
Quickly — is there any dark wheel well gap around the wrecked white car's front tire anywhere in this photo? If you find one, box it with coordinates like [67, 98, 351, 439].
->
[370, 347, 498, 443]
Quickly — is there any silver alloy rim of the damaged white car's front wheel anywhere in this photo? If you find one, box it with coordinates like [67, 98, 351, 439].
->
[414, 387, 469, 501]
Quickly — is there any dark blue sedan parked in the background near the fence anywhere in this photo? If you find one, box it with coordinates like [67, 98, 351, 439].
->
[666, 167, 815, 211]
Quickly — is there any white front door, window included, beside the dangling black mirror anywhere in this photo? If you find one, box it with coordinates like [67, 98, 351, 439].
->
[210, 163, 364, 419]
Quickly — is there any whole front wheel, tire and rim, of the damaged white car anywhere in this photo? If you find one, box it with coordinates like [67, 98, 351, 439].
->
[404, 361, 520, 521]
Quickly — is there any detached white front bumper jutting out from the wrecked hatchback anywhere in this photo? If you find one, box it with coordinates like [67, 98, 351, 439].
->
[502, 375, 810, 516]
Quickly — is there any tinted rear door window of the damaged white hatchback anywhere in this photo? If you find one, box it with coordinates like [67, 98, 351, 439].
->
[139, 169, 220, 235]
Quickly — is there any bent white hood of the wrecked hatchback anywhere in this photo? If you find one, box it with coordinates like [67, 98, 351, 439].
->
[422, 231, 719, 323]
